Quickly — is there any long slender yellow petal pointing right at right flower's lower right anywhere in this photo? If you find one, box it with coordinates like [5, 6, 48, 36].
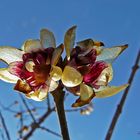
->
[95, 84, 128, 98]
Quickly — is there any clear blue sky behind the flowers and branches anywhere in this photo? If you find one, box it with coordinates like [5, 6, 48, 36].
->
[0, 0, 140, 140]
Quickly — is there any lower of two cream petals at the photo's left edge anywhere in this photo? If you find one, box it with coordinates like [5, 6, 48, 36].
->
[0, 68, 19, 83]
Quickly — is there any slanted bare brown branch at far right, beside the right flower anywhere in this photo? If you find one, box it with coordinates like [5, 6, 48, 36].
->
[105, 51, 140, 140]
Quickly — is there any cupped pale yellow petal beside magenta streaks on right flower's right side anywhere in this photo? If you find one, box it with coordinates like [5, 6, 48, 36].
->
[96, 64, 113, 86]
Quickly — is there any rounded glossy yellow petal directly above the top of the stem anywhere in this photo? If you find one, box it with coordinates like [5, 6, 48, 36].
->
[62, 66, 83, 87]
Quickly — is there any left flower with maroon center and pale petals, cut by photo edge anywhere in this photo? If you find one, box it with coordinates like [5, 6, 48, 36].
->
[0, 29, 64, 101]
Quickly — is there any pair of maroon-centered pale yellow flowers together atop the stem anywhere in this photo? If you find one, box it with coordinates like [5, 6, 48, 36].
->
[0, 26, 128, 107]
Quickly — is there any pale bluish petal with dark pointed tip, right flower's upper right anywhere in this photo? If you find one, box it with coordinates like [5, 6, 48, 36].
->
[96, 44, 128, 63]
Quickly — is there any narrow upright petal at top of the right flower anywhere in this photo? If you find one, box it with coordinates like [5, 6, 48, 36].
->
[64, 26, 76, 60]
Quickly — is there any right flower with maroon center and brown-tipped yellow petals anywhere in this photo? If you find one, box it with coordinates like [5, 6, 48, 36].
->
[62, 26, 128, 107]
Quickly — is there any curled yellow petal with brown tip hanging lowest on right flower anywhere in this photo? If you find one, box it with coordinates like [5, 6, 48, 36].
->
[72, 83, 95, 107]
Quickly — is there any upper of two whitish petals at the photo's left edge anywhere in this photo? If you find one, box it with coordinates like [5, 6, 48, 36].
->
[0, 46, 24, 64]
